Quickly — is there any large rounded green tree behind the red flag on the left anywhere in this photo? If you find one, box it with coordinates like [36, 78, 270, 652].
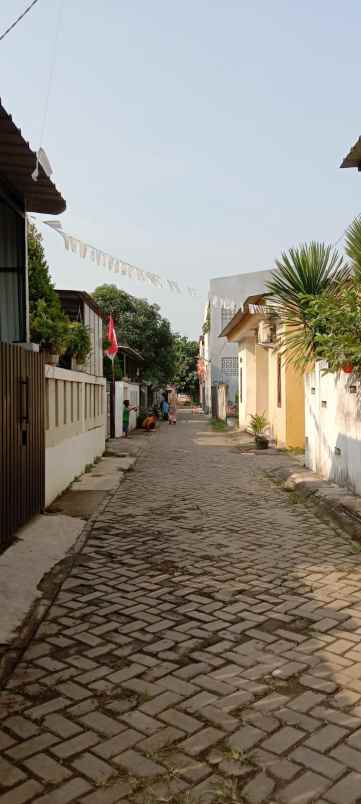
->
[93, 285, 176, 384]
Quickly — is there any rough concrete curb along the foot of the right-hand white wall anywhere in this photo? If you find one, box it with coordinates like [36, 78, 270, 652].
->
[265, 452, 361, 542]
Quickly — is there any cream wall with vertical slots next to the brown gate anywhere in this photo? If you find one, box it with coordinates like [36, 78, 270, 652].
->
[45, 365, 106, 505]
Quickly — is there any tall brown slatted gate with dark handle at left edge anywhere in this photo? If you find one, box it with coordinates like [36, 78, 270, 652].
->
[0, 343, 45, 548]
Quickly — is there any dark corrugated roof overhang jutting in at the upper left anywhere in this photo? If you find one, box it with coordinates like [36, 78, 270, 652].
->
[0, 100, 66, 215]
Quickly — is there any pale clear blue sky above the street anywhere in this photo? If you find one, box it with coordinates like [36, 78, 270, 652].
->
[0, 0, 361, 336]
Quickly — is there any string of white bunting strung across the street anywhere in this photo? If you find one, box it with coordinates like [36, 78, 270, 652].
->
[42, 221, 239, 311]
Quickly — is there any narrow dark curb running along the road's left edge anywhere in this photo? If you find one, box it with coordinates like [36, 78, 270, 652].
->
[0, 440, 144, 691]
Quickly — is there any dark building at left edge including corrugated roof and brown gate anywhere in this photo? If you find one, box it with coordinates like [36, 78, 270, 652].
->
[0, 97, 65, 548]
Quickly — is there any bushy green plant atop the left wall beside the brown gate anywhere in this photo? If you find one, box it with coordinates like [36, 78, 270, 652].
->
[30, 299, 69, 366]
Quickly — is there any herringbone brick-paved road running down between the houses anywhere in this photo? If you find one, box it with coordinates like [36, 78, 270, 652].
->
[0, 414, 361, 804]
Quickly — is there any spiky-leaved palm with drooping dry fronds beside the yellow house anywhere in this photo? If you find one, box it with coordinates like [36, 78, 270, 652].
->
[267, 242, 350, 371]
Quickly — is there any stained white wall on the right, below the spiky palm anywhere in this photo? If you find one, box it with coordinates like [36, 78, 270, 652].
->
[305, 362, 361, 494]
